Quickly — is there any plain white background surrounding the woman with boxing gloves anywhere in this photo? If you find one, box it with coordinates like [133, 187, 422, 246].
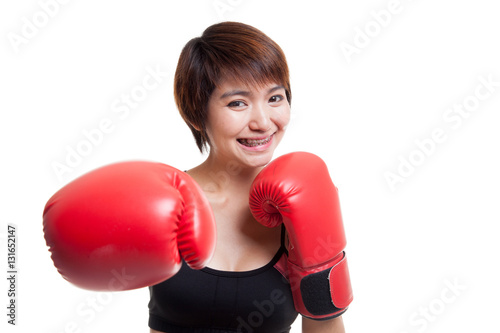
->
[0, 0, 500, 333]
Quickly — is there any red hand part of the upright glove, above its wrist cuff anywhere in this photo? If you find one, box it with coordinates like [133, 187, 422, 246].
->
[250, 152, 346, 267]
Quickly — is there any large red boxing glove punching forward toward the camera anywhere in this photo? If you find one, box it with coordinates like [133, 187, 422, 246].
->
[43, 162, 215, 291]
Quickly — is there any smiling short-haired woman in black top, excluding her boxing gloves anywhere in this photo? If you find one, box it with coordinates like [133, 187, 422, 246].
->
[149, 22, 344, 333]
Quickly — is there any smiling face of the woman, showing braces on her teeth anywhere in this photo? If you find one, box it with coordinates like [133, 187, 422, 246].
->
[206, 80, 290, 167]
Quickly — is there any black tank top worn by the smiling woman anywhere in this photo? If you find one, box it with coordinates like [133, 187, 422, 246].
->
[149, 236, 297, 333]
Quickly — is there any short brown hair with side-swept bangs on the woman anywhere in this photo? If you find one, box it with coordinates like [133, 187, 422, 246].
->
[174, 22, 292, 152]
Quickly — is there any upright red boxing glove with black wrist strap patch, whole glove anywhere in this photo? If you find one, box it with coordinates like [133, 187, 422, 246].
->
[250, 152, 353, 319]
